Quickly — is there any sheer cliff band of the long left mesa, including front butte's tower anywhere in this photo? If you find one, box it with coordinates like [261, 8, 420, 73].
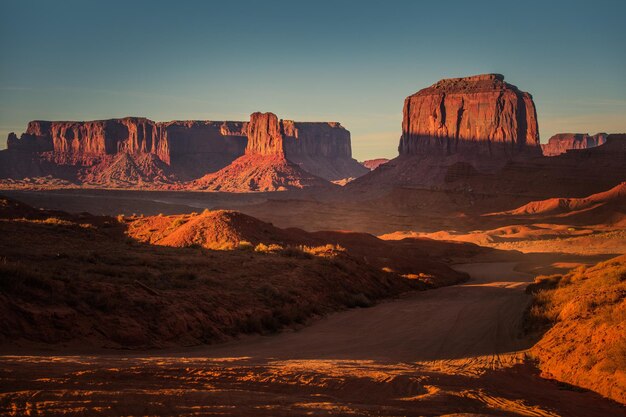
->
[7, 113, 367, 180]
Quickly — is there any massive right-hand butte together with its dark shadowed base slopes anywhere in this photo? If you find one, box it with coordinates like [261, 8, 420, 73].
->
[346, 74, 626, 198]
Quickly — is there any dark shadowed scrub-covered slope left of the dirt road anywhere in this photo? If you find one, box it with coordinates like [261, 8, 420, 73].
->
[0, 202, 420, 348]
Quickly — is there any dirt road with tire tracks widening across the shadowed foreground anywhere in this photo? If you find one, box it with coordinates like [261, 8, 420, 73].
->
[0, 263, 626, 417]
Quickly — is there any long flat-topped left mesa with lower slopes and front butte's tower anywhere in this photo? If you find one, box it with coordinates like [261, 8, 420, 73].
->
[0, 113, 366, 186]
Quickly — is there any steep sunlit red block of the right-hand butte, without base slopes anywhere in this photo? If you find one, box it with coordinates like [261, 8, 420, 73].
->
[398, 74, 541, 158]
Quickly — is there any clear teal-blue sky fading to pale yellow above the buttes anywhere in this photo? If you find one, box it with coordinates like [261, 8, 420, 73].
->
[0, 0, 626, 159]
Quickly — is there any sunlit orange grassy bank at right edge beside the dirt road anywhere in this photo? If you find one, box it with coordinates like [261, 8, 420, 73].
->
[526, 256, 626, 403]
